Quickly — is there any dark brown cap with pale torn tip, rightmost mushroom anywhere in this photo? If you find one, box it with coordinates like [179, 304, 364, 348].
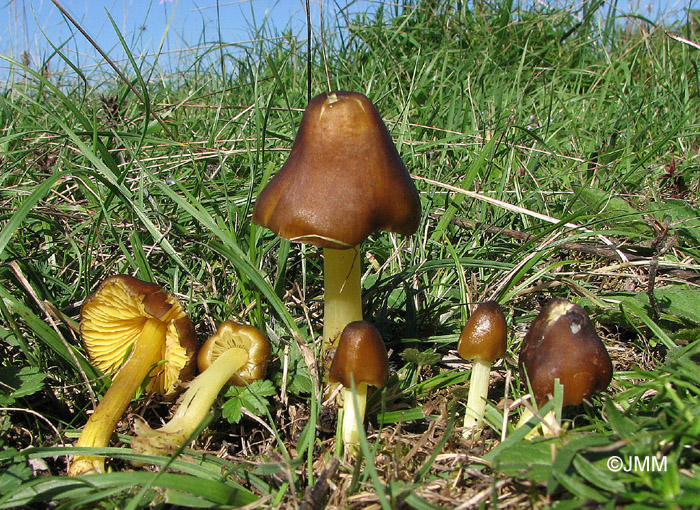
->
[518, 299, 613, 406]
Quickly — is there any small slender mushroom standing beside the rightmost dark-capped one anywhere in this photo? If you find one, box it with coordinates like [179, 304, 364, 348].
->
[457, 301, 507, 436]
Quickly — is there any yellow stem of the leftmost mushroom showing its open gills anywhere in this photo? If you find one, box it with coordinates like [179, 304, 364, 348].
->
[68, 319, 167, 476]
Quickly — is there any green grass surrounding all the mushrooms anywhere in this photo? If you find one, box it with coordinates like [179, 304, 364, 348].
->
[0, 1, 700, 508]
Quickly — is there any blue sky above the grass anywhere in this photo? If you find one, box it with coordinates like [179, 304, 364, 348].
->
[0, 0, 700, 80]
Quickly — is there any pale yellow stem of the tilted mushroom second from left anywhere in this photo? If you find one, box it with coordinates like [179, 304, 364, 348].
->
[131, 347, 248, 456]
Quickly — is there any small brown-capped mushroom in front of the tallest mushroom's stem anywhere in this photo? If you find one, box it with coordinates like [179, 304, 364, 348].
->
[329, 321, 389, 451]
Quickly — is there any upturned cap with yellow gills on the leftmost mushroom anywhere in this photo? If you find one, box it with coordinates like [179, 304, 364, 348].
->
[80, 275, 197, 395]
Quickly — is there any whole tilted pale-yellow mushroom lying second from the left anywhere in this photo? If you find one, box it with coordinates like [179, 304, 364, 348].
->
[131, 321, 270, 456]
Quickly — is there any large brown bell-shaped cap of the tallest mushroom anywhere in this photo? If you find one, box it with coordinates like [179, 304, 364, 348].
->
[253, 91, 420, 249]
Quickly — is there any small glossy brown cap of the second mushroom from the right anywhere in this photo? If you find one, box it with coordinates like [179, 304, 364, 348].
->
[457, 301, 507, 363]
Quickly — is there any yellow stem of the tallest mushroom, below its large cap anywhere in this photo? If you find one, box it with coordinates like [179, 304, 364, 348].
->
[321, 246, 362, 360]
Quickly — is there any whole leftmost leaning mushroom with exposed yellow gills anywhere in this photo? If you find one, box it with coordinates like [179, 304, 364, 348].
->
[68, 275, 197, 476]
